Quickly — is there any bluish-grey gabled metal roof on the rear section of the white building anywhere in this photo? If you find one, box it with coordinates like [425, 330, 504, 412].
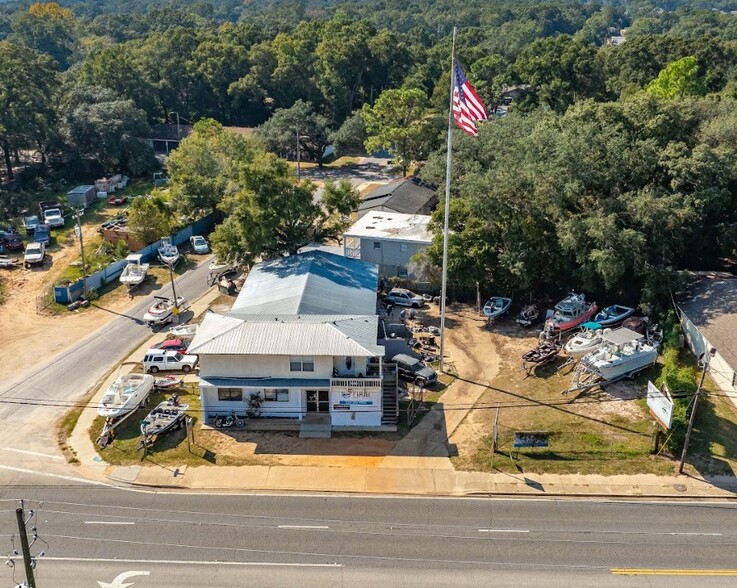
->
[231, 251, 379, 315]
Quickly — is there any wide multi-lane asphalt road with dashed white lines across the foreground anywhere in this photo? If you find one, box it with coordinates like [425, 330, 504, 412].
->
[0, 487, 737, 588]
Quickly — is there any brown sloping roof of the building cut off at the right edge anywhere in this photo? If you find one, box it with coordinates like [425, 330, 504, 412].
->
[678, 275, 737, 370]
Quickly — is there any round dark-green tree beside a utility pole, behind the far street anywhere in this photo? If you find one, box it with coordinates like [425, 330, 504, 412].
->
[257, 100, 330, 166]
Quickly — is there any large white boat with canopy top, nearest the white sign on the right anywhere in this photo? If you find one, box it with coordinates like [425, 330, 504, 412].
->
[580, 328, 658, 381]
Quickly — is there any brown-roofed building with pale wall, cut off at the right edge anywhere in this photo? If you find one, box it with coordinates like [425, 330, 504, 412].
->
[678, 274, 737, 405]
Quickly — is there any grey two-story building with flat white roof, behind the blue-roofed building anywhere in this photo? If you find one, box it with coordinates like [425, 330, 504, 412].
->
[343, 211, 432, 277]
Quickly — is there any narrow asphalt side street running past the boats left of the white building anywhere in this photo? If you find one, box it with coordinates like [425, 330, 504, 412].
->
[0, 257, 211, 469]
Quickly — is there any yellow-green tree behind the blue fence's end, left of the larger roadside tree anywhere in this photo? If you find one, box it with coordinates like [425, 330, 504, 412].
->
[166, 119, 261, 219]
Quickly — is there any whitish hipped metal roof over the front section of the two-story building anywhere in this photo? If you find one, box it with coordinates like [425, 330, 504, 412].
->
[187, 313, 384, 357]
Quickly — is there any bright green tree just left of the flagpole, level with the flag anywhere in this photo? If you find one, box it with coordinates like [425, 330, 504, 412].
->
[361, 88, 433, 175]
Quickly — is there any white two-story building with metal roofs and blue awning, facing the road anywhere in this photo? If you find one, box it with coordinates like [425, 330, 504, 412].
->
[189, 251, 397, 428]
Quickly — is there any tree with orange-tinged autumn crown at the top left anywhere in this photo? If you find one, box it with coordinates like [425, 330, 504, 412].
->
[13, 2, 79, 70]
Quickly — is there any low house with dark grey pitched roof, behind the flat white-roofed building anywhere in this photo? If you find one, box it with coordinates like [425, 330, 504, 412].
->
[356, 176, 438, 218]
